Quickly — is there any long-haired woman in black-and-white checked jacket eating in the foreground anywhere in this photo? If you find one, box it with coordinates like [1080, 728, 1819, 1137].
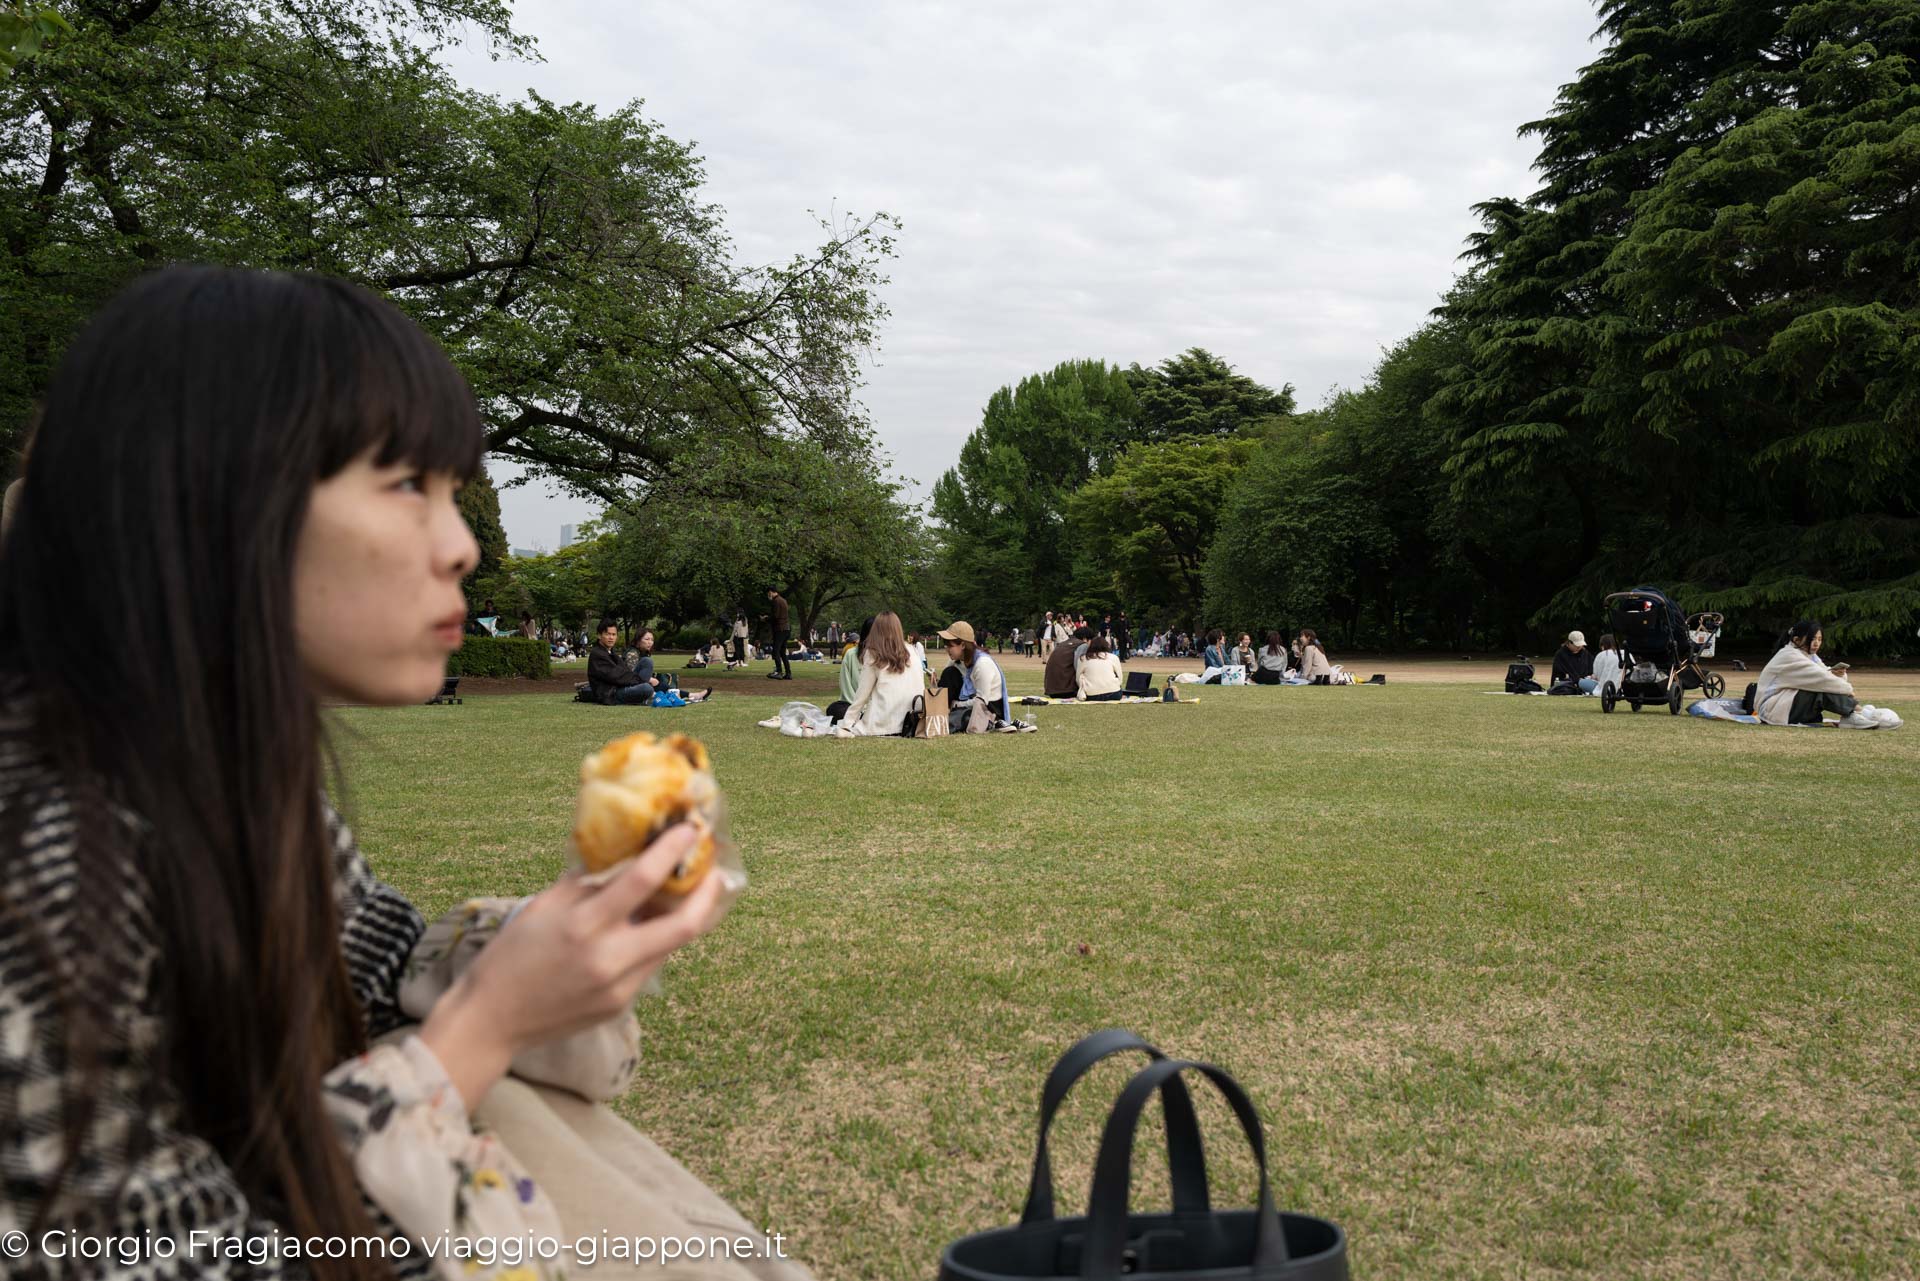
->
[0, 269, 804, 1279]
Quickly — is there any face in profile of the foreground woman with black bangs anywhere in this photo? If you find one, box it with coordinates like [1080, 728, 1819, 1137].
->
[294, 455, 480, 705]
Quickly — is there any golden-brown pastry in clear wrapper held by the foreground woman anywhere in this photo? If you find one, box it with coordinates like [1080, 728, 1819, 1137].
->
[568, 734, 747, 991]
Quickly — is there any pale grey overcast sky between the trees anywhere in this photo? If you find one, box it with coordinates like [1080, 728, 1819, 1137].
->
[451, 0, 1597, 549]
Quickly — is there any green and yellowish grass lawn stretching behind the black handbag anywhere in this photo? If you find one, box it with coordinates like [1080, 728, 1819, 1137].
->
[340, 659, 1920, 1281]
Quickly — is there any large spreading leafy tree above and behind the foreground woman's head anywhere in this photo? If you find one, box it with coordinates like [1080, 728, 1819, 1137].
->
[0, 0, 895, 503]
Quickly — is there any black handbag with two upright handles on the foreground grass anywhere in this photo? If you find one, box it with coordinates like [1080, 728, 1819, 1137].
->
[941, 1029, 1348, 1281]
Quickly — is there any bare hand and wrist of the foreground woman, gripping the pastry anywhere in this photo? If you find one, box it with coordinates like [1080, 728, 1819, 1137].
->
[420, 824, 722, 1108]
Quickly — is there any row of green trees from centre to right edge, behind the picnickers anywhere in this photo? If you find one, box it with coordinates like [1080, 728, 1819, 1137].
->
[933, 0, 1920, 653]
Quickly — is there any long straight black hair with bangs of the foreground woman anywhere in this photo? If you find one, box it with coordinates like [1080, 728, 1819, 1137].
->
[0, 267, 482, 1277]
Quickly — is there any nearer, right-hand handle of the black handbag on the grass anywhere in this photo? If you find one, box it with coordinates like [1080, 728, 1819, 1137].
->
[1081, 1058, 1288, 1281]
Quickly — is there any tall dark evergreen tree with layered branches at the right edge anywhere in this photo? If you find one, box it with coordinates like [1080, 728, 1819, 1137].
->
[1434, 0, 1920, 643]
